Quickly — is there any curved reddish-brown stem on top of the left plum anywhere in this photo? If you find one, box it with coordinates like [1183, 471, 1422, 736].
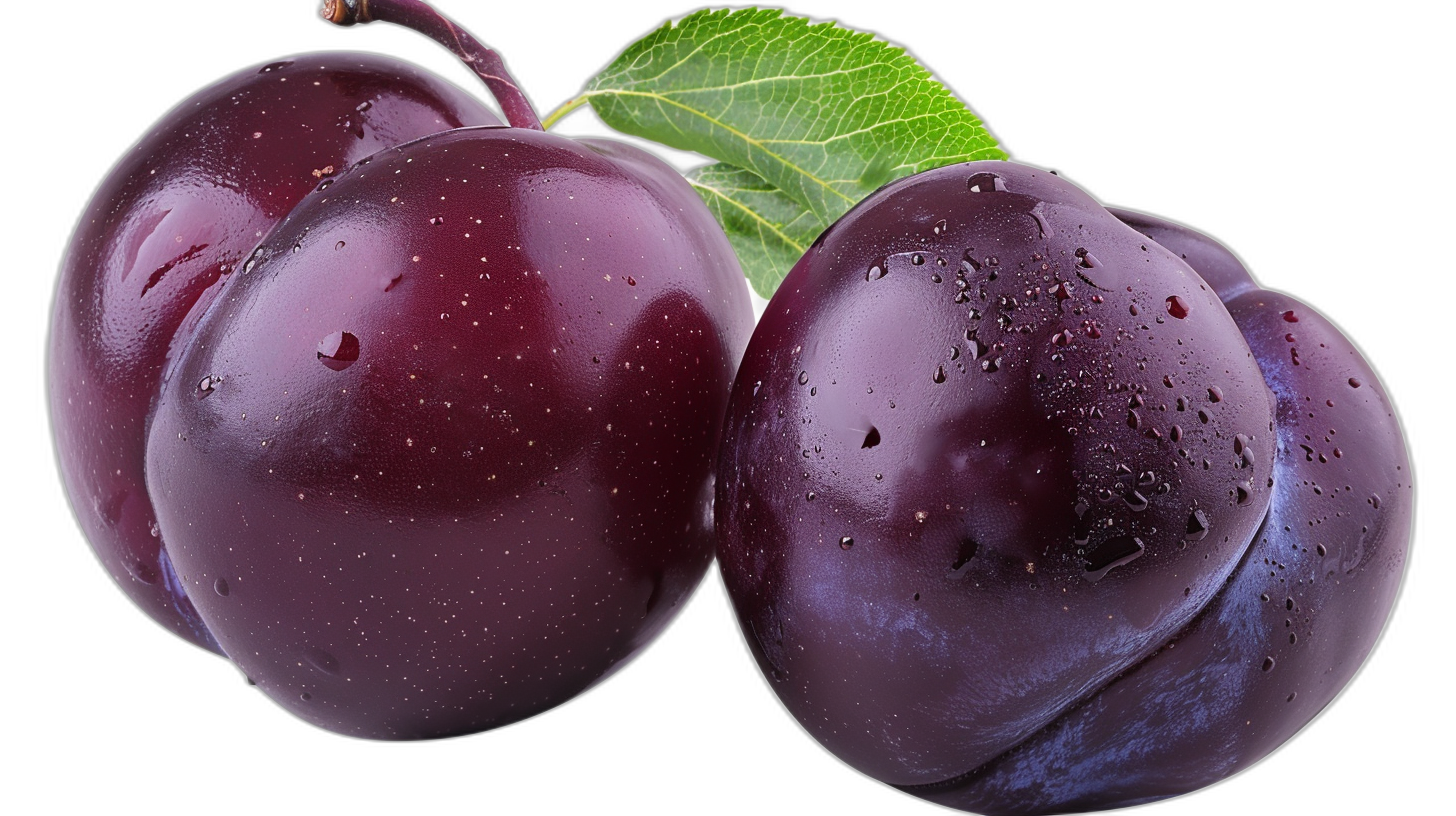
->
[319, 0, 542, 130]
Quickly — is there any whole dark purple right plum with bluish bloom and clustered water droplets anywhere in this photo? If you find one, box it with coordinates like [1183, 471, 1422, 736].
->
[716, 163, 1414, 815]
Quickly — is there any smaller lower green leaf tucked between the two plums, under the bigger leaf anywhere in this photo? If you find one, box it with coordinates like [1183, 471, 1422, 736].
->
[686, 162, 826, 299]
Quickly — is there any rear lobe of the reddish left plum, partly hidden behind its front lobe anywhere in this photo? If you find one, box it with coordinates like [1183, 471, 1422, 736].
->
[47, 51, 499, 653]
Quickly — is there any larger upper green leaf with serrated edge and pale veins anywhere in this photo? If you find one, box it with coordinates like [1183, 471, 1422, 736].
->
[574, 9, 1006, 224]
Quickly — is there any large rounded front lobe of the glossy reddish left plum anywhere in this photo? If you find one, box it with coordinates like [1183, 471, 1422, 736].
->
[147, 128, 753, 739]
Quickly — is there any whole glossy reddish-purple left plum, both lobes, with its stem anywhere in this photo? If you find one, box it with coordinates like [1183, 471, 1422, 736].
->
[47, 0, 753, 740]
